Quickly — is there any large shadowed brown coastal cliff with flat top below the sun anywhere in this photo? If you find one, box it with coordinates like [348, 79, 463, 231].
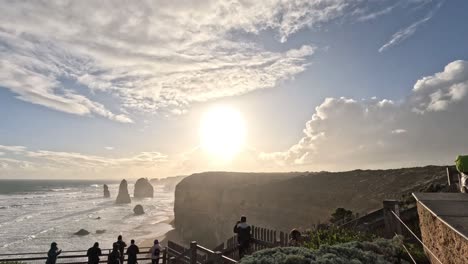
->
[174, 166, 446, 247]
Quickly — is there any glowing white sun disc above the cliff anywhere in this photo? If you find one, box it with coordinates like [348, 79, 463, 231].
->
[200, 106, 246, 160]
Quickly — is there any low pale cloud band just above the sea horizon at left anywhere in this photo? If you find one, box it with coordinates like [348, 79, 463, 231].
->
[0, 145, 169, 178]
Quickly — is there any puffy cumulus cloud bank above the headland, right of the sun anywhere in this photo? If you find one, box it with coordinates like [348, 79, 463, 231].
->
[260, 61, 468, 170]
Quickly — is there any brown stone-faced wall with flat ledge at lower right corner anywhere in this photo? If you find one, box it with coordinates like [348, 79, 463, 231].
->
[413, 193, 468, 264]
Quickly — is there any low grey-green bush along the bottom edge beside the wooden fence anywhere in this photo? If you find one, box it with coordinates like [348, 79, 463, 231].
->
[240, 238, 401, 264]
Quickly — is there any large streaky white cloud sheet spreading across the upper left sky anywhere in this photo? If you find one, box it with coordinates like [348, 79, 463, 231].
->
[0, 0, 428, 120]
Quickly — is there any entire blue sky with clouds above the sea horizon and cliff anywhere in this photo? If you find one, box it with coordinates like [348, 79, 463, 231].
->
[0, 0, 468, 179]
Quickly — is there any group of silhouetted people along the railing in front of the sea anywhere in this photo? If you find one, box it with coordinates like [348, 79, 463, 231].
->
[46, 236, 161, 264]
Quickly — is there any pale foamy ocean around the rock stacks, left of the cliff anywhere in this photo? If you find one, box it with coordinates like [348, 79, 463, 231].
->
[0, 180, 174, 254]
